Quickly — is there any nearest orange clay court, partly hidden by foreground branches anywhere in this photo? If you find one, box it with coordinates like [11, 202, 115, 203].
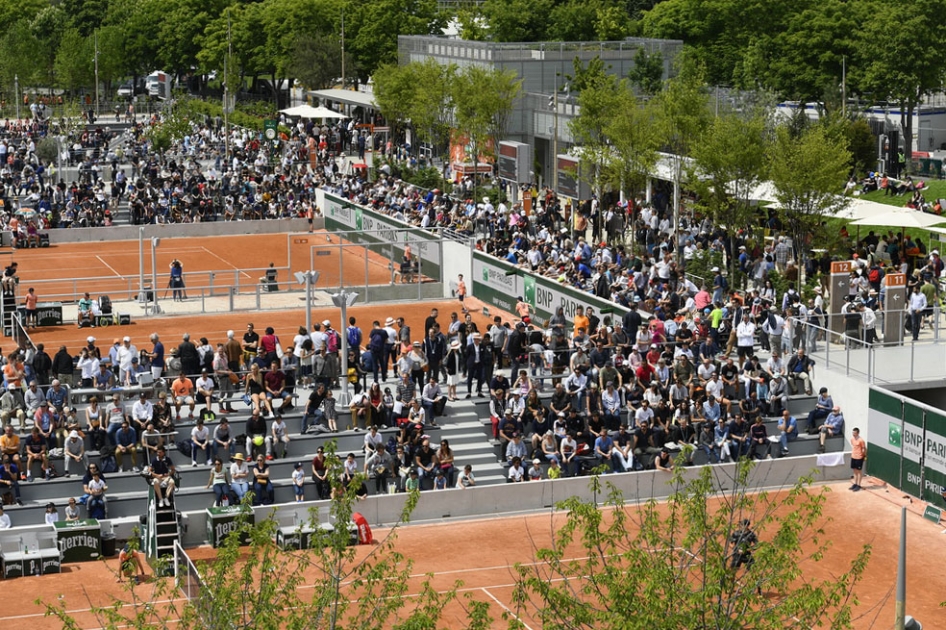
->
[0, 483, 946, 630]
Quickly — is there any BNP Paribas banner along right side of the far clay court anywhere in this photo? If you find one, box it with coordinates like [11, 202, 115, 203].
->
[322, 193, 441, 279]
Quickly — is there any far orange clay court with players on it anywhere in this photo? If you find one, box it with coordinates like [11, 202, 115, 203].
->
[3, 231, 416, 302]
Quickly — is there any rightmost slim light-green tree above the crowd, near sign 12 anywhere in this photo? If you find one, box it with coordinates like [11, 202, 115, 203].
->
[768, 125, 851, 278]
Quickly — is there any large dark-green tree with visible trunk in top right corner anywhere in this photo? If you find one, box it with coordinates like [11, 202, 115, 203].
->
[860, 0, 946, 174]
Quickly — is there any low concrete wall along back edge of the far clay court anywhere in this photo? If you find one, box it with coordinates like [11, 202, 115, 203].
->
[45, 217, 325, 245]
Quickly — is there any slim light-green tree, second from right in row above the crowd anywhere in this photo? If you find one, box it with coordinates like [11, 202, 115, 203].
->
[689, 109, 772, 278]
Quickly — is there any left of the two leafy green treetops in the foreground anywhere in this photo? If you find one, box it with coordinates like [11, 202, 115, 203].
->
[41, 444, 495, 630]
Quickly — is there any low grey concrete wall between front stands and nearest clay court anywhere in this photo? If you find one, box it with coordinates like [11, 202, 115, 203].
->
[177, 455, 850, 547]
